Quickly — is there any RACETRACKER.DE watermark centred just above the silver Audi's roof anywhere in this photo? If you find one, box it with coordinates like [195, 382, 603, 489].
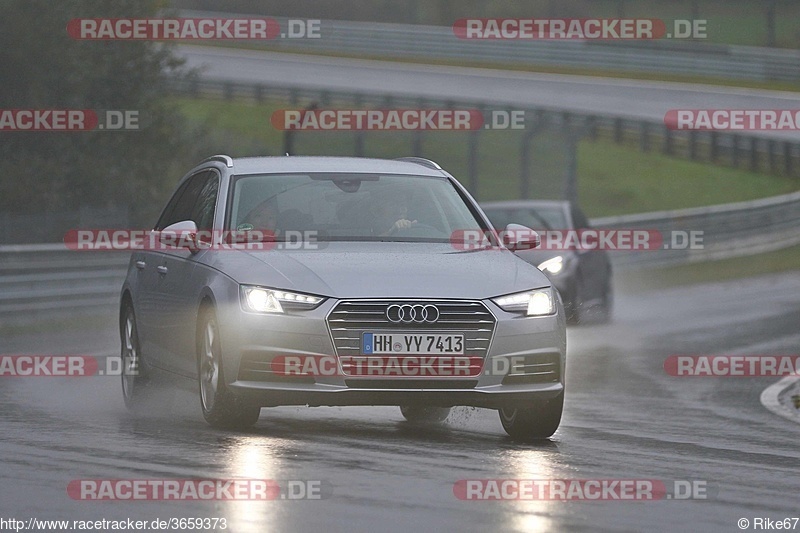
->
[270, 108, 525, 131]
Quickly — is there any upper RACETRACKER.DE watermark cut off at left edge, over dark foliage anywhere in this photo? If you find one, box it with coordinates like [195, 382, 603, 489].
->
[0, 109, 140, 131]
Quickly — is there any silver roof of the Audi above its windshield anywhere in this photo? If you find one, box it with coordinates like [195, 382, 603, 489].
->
[227, 156, 446, 178]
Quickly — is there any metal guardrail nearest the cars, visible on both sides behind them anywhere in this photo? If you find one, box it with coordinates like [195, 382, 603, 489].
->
[0, 192, 800, 323]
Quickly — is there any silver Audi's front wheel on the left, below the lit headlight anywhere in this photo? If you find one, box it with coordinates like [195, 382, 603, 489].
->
[197, 306, 261, 429]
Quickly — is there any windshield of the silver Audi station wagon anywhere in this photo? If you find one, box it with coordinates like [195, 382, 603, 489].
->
[227, 173, 482, 242]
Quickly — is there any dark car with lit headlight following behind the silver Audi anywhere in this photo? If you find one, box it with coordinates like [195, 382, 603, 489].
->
[481, 200, 614, 324]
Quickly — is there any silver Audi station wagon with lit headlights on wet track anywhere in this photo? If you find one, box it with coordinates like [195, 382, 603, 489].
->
[120, 156, 566, 440]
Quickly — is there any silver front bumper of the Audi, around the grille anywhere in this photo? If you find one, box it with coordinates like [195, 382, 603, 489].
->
[220, 300, 566, 408]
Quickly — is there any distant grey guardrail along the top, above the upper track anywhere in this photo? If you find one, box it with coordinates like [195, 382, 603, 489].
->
[180, 10, 800, 82]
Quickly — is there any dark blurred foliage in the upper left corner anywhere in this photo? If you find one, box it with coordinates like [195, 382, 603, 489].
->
[0, 0, 212, 224]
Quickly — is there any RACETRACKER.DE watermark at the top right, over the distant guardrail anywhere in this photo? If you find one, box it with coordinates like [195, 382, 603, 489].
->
[453, 18, 708, 40]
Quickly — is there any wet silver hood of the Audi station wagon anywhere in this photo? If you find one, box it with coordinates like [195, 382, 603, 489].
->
[204, 242, 550, 299]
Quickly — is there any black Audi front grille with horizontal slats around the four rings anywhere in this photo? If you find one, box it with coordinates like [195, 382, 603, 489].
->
[328, 300, 496, 374]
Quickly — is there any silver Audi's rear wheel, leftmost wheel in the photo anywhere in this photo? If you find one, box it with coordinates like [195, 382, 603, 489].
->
[119, 302, 151, 412]
